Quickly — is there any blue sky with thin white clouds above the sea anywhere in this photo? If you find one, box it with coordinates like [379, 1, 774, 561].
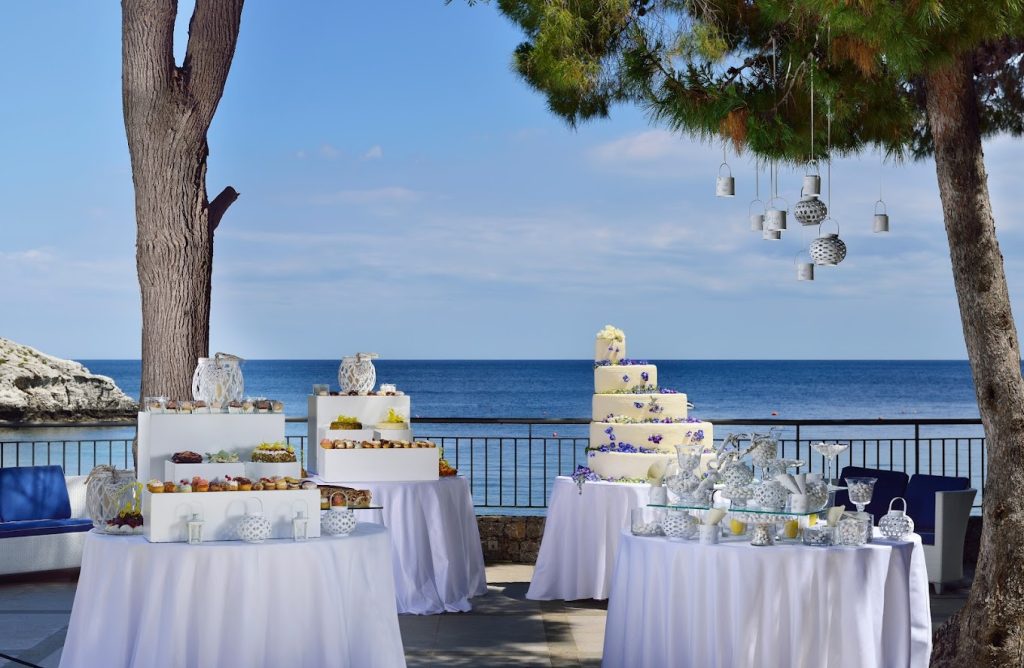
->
[0, 0, 1024, 359]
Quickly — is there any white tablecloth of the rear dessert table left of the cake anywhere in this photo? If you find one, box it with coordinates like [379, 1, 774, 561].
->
[327, 476, 487, 615]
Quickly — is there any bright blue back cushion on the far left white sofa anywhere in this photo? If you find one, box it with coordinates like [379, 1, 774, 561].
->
[0, 466, 71, 521]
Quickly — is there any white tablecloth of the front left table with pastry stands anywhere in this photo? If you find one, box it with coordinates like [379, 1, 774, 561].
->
[60, 524, 406, 668]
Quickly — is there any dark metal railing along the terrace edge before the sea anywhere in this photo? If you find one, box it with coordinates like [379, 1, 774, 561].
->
[0, 417, 987, 512]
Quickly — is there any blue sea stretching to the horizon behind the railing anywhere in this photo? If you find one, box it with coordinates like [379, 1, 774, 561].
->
[0, 360, 984, 506]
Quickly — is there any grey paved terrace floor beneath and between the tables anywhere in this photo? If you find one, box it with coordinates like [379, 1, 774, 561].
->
[0, 565, 967, 668]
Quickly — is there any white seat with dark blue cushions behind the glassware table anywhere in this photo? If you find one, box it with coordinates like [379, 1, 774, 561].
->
[836, 466, 978, 593]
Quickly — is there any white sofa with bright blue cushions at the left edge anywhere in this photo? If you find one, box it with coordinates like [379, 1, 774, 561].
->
[0, 466, 92, 575]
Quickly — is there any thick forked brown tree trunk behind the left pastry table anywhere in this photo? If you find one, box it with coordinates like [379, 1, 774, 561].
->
[122, 0, 243, 399]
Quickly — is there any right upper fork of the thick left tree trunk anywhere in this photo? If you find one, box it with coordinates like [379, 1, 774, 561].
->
[181, 0, 245, 125]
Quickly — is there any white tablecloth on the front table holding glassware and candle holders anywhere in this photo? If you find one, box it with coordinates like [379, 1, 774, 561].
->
[603, 533, 932, 668]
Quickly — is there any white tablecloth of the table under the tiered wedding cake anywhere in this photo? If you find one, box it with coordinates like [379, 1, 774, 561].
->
[526, 476, 649, 600]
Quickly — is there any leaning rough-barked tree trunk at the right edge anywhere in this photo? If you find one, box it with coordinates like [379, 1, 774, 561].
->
[927, 55, 1024, 668]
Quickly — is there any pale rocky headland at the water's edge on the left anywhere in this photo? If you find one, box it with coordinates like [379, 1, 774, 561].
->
[0, 337, 138, 422]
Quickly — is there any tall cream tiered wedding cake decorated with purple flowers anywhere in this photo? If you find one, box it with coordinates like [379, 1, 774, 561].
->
[587, 325, 715, 479]
